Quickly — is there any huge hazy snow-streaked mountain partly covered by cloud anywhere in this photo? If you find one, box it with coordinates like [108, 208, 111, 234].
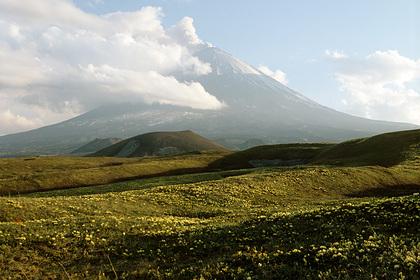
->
[0, 45, 417, 156]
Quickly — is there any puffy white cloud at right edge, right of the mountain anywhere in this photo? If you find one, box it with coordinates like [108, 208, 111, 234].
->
[334, 50, 420, 124]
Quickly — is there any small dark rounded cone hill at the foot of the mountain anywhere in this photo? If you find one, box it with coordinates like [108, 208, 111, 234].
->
[93, 130, 227, 157]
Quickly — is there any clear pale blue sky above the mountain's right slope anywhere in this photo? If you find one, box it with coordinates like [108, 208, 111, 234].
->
[75, 0, 420, 111]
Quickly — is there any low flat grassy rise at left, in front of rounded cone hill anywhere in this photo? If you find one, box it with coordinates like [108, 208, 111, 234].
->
[0, 153, 223, 195]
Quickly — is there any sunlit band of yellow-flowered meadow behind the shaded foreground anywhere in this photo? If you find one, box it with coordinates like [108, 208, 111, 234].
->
[0, 166, 420, 222]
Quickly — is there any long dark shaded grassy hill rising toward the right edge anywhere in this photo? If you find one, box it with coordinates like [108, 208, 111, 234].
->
[210, 130, 420, 169]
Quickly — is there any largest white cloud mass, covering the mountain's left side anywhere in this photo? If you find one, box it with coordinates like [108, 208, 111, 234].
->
[0, 0, 224, 133]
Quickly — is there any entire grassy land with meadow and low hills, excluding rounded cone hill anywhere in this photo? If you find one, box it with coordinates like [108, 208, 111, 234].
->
[0, 130, 420, 279]
